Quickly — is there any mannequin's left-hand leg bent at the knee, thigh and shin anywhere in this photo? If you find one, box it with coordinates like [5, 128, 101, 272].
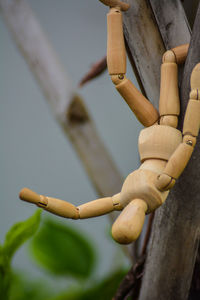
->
[107, 7, 159, 126]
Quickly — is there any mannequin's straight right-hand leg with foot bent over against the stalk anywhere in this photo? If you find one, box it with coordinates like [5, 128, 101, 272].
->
[159, 44, 189, 128]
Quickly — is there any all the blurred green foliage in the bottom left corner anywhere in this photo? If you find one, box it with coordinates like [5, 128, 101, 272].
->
[0, 210, 125, 300]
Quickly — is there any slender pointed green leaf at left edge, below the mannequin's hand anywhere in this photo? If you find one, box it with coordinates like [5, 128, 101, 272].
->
[3, 209, 41, 260]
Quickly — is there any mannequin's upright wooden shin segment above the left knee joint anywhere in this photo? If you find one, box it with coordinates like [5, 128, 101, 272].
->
[107, 8, 126, 75]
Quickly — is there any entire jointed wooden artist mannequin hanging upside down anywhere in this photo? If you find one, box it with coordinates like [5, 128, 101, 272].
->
[20, 0, 200, 244]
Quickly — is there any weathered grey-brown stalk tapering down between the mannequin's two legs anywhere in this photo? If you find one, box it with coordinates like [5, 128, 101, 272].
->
[123, 0, 165, 107]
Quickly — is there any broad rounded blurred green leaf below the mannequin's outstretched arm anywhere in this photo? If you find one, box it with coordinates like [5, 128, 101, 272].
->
[31, 219, 95, 279]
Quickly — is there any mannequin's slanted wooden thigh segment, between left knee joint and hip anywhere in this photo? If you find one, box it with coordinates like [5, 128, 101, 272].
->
[116, 78, 159, 127]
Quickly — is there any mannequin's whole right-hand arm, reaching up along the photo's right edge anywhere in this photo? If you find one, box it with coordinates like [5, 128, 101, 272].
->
[156, 64, 200, 190]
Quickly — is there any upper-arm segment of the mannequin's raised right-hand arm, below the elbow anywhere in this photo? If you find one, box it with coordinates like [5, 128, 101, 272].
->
[163, 143, 194, 179]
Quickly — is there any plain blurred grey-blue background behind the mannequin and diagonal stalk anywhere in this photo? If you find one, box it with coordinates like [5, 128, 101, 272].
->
[0, 0, 142, 296]
